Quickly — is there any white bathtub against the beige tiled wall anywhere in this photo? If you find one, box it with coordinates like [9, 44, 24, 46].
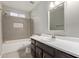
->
[2, 38, 31, 54]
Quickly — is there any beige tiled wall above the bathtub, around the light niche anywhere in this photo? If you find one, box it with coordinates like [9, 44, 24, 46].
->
[3, 15, 30, 41]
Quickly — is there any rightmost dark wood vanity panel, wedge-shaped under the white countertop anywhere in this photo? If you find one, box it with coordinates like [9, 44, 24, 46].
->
[55, 49, 74, 58]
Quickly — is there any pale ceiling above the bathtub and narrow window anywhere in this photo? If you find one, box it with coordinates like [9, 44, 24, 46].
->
[1, 1, 38, 12]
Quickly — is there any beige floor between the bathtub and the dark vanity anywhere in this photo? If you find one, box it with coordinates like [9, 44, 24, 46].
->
[2, 48, 32, 58]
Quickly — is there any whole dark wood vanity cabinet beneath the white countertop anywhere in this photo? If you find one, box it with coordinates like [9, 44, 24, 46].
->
[31, 39, 75, 58]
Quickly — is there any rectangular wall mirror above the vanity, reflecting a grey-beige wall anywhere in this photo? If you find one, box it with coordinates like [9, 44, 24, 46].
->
[48, 1, 64, 30]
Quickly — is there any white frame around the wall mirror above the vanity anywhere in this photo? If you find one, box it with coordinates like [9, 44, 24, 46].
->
[48, 2, 65, 35]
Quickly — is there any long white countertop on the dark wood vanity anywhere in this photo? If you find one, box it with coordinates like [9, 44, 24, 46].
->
[31, 35, 79, 57]
